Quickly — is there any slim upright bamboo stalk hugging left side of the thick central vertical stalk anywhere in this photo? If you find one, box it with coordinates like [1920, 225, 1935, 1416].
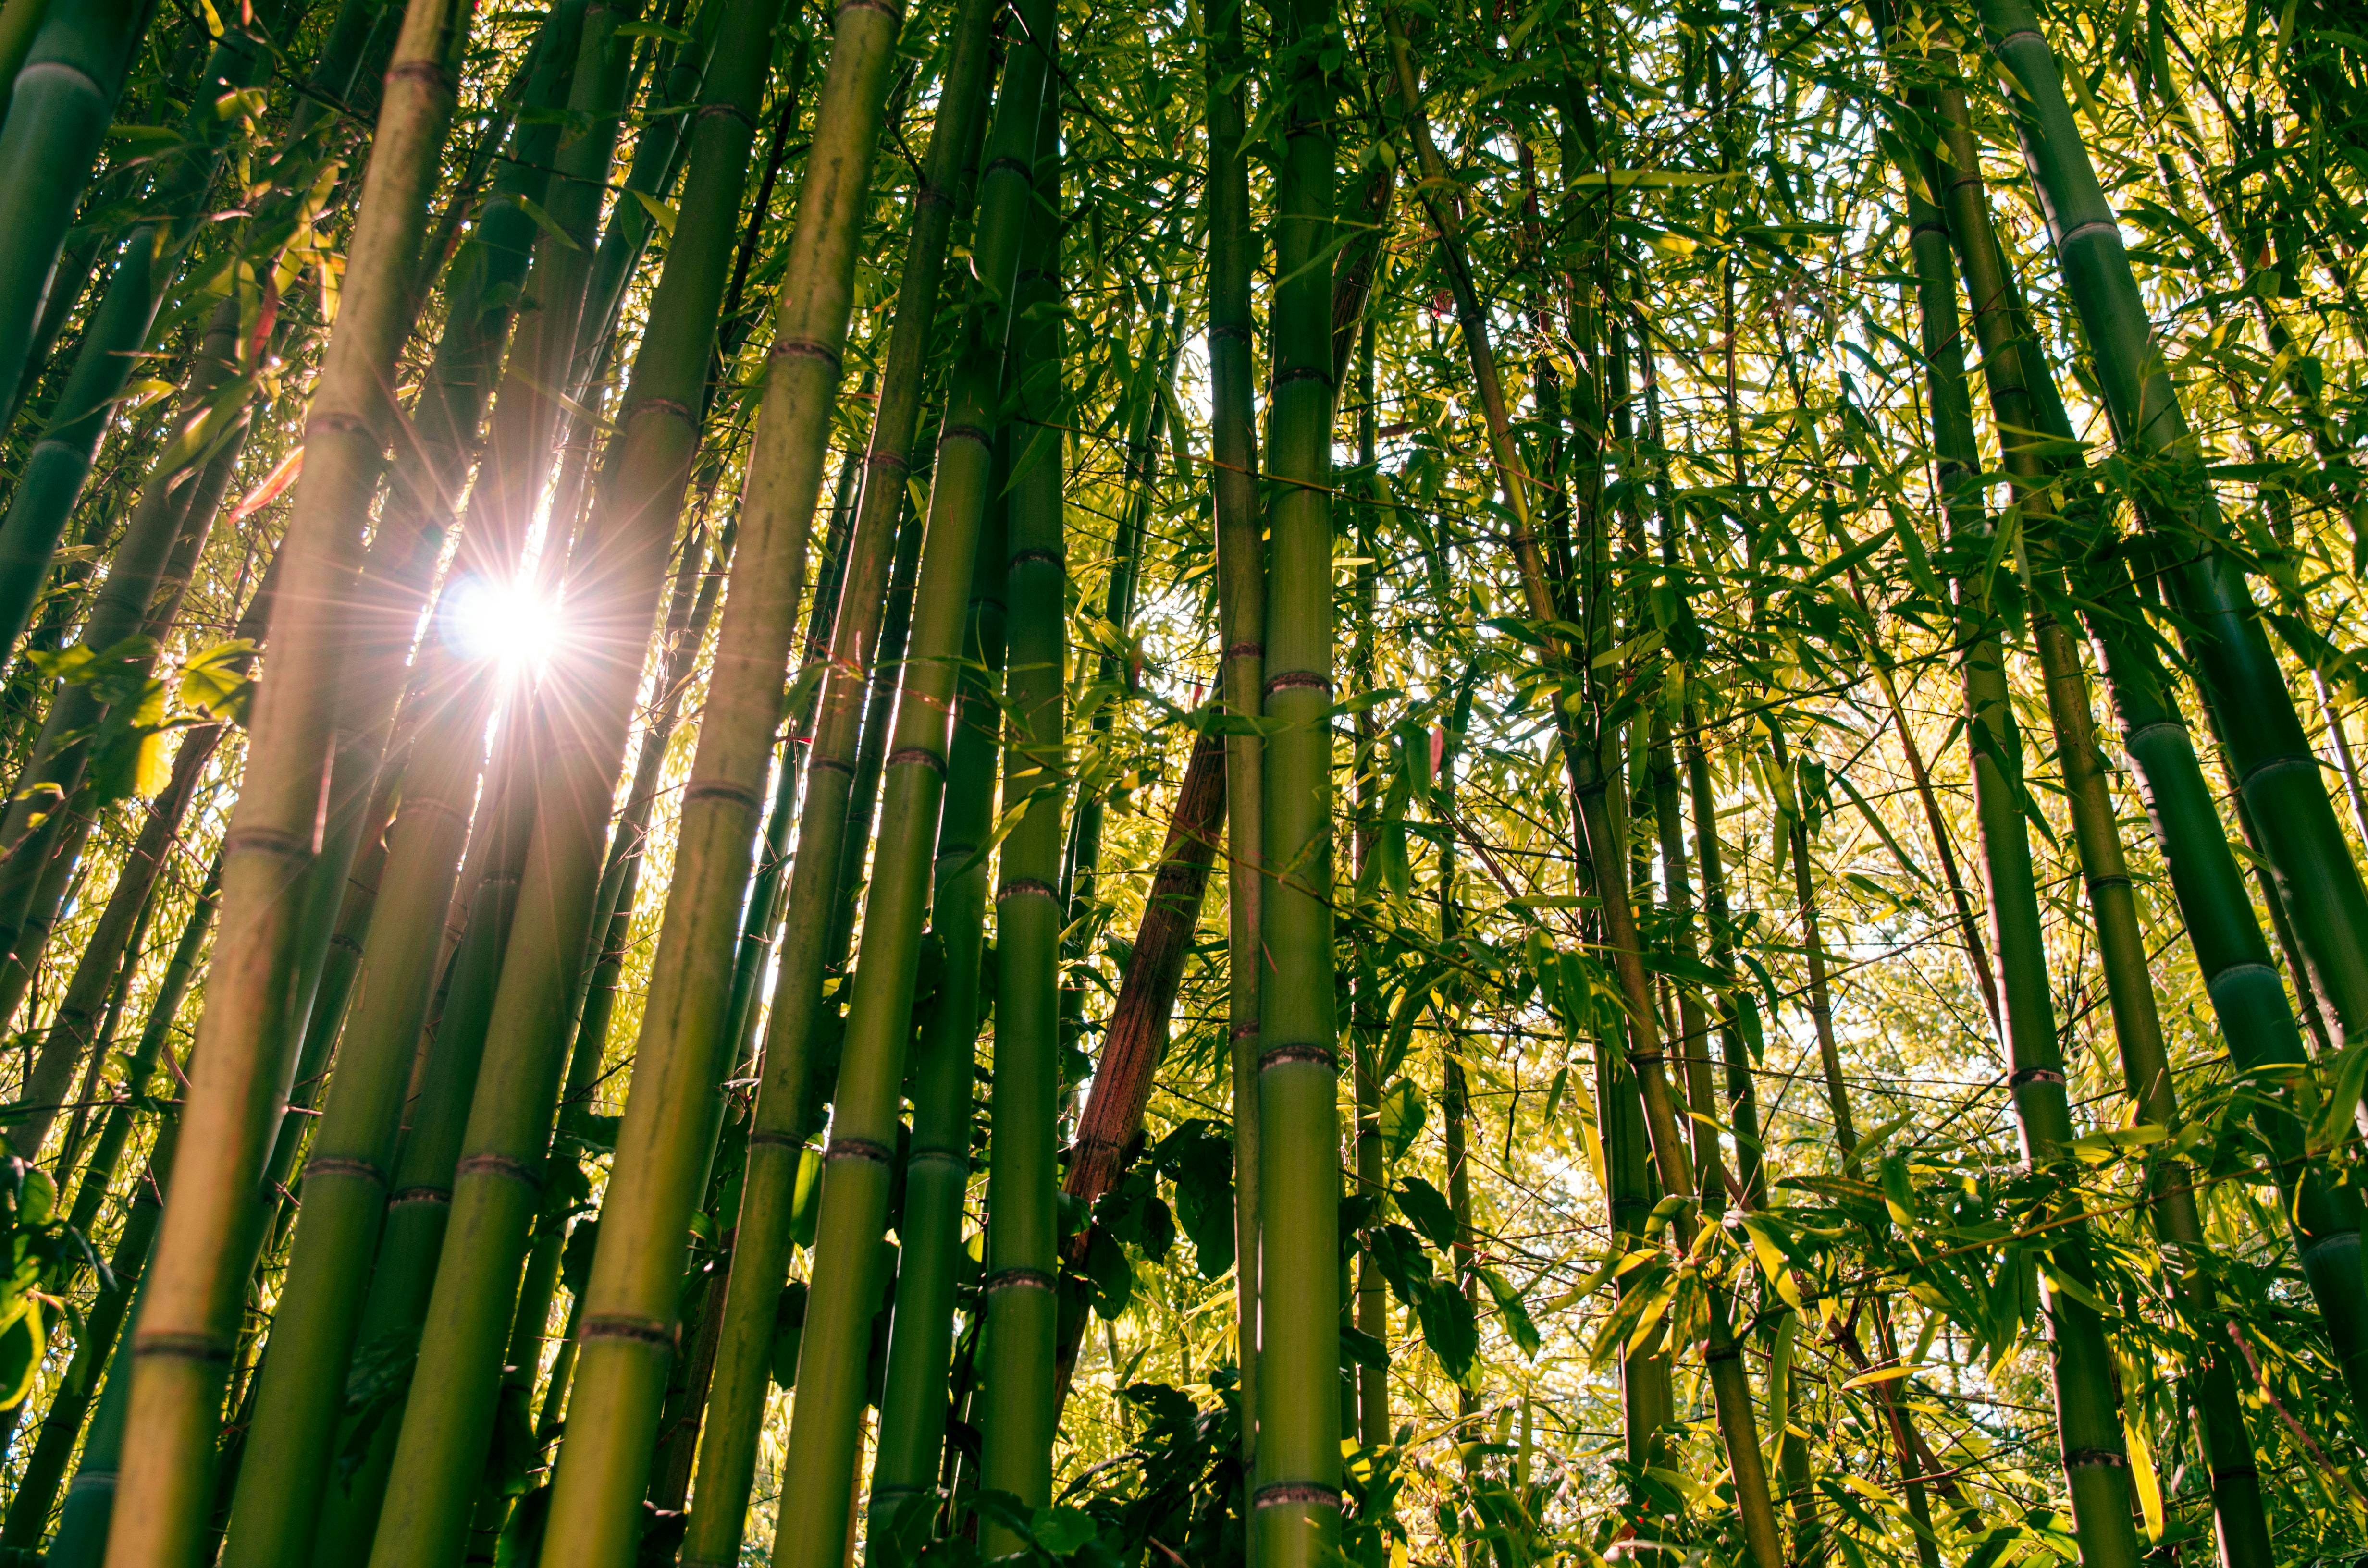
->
[1203, 0, 1267, 1478]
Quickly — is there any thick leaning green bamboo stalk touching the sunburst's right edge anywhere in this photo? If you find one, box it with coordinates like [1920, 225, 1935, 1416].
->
[350, 5, 795, 1563]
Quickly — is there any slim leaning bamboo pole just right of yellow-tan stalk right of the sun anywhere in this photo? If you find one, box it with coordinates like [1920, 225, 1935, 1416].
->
[682, 0, 995, 1568]
